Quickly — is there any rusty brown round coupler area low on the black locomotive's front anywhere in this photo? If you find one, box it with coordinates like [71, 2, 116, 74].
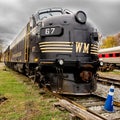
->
[80, 71, 92, 82]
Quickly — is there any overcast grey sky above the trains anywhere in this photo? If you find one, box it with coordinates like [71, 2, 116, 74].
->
[0, 0, 120, 48]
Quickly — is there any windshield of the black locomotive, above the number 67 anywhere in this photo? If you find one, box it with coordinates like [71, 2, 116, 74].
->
[39, 11, 63, 20]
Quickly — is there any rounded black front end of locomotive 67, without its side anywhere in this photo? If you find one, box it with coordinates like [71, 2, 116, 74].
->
[38, 8, 99, 95]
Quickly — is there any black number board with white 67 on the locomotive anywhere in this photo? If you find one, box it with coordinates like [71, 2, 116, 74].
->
[40, 26, 63, 37]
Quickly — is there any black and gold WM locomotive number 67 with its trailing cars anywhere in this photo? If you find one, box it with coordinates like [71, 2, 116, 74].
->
[4, 8, 99, 95]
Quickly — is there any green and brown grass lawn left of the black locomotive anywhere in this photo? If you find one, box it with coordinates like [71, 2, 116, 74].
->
[0, 63, 69, 120]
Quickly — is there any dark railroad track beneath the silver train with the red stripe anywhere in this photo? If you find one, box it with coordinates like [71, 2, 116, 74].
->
[98, 76, 120, 86]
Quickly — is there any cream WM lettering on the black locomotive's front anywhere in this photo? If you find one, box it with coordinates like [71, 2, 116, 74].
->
[76, 42, 90, 53]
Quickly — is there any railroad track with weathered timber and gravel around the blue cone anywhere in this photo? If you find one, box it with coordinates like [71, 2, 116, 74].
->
[55, 94, 120, 120]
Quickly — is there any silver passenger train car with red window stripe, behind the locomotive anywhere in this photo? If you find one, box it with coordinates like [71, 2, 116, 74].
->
[98, 46, 120, 72]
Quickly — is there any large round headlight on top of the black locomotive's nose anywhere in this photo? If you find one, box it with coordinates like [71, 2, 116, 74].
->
[75, 11, 87, 24]
